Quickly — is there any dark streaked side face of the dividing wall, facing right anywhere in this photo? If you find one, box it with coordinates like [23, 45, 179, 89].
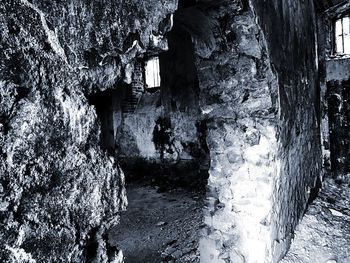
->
[253, 0, 322, 260]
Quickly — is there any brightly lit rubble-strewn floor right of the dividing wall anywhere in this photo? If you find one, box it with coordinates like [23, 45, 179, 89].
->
[281, 176, 350, 263]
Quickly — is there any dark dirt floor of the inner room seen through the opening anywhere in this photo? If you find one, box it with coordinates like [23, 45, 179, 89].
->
[109, 183, 205, 263]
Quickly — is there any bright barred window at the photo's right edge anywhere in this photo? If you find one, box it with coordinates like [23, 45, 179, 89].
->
[335, 16, 350, 54]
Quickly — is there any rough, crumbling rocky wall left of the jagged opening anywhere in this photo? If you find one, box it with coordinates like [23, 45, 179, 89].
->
[0, 0, 176, 262]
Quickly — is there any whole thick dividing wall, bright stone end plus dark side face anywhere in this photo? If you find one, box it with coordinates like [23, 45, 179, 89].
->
[194, 1, 321, 262]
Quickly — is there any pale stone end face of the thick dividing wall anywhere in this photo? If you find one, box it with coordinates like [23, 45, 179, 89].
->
[194, 2, 278, 262]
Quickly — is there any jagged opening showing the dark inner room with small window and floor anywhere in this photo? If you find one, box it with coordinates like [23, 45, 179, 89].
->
[90, 1, 210, 262]
